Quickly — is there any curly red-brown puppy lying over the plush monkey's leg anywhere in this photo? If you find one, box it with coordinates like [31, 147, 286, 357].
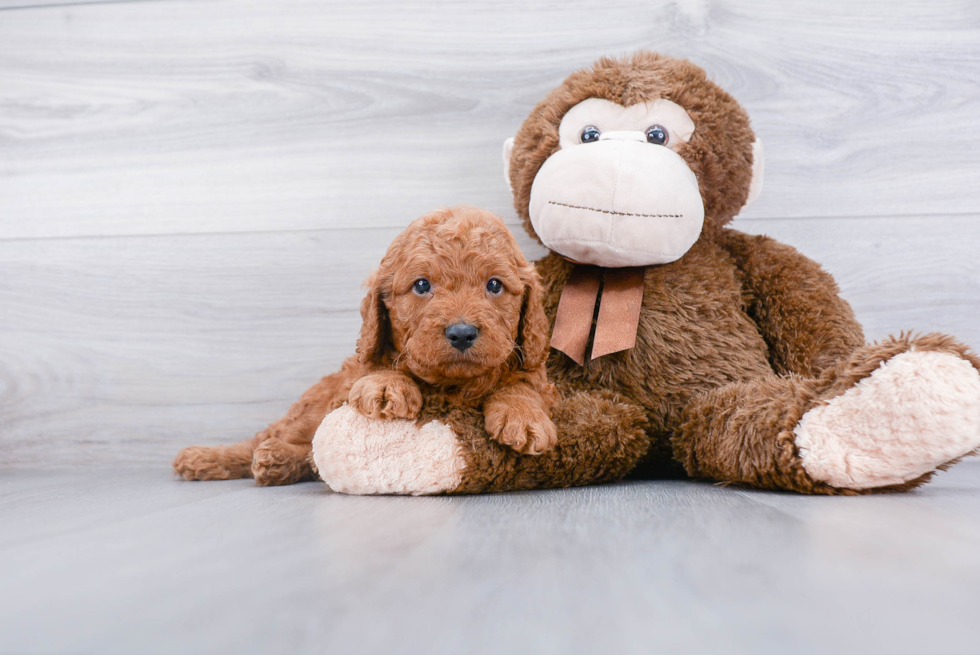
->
[173, 207, 557, 485]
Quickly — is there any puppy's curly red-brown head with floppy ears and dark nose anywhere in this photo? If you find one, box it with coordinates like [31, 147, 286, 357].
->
[357, 207, 548, 384]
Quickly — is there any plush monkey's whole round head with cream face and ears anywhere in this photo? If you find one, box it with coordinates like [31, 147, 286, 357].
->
[504, 52, 762, 268]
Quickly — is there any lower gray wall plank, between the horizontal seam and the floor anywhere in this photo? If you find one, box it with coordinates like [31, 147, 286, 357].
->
[0, 216, 980, 467]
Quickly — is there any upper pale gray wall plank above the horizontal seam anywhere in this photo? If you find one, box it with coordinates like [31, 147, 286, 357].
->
[0, 0, 980, 238]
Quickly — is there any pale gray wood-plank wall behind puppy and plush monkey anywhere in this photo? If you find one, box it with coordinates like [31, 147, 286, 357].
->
[0, 0, 980, 468]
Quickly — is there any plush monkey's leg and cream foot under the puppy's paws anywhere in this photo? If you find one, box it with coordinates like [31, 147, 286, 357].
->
[313, 391, 650, 495]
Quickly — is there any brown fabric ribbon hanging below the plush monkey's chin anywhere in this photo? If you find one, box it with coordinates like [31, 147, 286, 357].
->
[551, 264, 646, 366]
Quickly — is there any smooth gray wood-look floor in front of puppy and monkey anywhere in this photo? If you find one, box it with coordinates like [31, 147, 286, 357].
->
[0, 462, 980, 655]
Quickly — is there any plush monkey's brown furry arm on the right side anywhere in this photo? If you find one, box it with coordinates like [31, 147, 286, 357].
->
[718, 229, 864, 376]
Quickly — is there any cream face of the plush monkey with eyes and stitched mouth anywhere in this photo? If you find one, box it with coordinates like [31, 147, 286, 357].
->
[529, 98, 704, 267]
